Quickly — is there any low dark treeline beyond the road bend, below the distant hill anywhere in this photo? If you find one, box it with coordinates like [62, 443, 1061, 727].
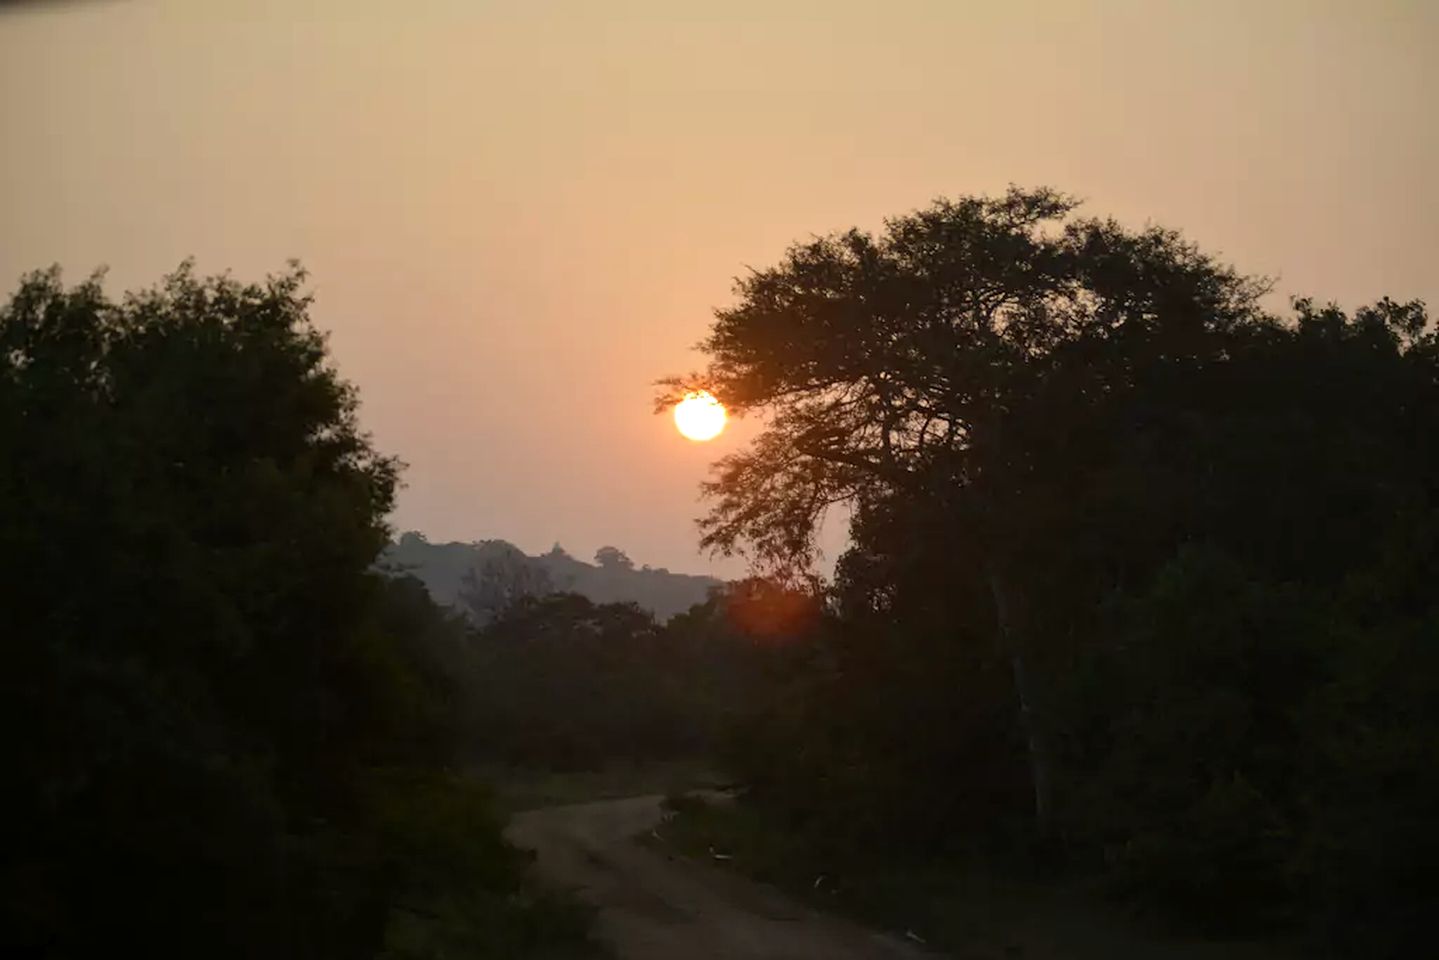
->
[463, 580, 809, 771]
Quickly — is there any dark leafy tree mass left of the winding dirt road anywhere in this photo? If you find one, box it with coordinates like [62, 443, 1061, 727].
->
[0, 269, 583, 959]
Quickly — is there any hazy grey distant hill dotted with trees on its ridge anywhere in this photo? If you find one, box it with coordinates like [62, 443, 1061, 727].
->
[381, 531, 724, 622]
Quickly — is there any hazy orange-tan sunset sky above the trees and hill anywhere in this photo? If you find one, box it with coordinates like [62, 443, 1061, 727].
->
[0, 0, 1439, 573]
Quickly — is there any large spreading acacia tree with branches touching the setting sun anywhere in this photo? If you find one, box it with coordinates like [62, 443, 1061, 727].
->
[661, 189, 1275, 820]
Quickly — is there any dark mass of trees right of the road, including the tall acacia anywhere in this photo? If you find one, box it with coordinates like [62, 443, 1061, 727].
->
[679, 190, 1439, 957]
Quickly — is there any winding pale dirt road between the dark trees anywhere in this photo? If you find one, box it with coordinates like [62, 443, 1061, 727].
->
[509, 796, 934, 960]
